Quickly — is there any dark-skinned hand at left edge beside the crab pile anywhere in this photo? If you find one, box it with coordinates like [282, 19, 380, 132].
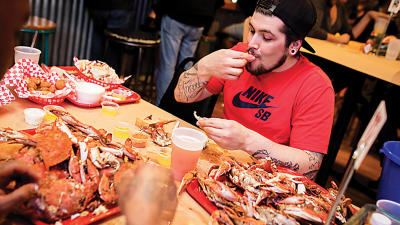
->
[0, 161, 39, 215]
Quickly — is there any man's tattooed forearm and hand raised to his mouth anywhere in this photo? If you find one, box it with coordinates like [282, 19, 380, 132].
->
[174, 49, 255, 103]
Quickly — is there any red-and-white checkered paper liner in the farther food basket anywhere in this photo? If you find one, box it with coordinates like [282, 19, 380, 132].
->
[73, 57, 125, 88]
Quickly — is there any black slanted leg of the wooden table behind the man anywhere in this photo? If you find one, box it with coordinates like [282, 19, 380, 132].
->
[315, 71, 365, 187]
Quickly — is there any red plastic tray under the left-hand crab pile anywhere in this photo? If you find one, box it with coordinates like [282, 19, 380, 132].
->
[22, 129, 121, 225]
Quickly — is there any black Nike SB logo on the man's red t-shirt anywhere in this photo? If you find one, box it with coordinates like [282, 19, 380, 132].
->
[232, 86, 277, 121]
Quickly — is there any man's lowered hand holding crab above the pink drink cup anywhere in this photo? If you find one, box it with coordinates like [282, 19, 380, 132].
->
[197, 117, 252, 149]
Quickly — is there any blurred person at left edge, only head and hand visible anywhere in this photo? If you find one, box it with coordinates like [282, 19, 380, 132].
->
[0, 0, 43, 220]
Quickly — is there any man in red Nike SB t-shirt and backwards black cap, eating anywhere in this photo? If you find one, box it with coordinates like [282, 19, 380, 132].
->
[175, 0, 334, 178]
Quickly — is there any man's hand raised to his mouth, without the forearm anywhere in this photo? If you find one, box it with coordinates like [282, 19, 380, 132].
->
[198, 49, 255, 80]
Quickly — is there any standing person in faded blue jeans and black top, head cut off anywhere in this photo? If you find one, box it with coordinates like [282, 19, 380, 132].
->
[153, 0, 224, 105]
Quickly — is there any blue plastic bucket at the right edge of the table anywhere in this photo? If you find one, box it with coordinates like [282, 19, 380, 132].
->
[377, 141, 400, 203]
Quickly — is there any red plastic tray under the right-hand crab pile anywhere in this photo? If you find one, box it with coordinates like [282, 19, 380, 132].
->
[186, 167, 328, 214]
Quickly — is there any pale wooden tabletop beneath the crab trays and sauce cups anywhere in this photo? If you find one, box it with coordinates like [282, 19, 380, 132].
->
[0, 98, 210, 225]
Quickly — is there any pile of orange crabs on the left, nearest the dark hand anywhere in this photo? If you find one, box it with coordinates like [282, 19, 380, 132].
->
[0, 109, 143, 222]
